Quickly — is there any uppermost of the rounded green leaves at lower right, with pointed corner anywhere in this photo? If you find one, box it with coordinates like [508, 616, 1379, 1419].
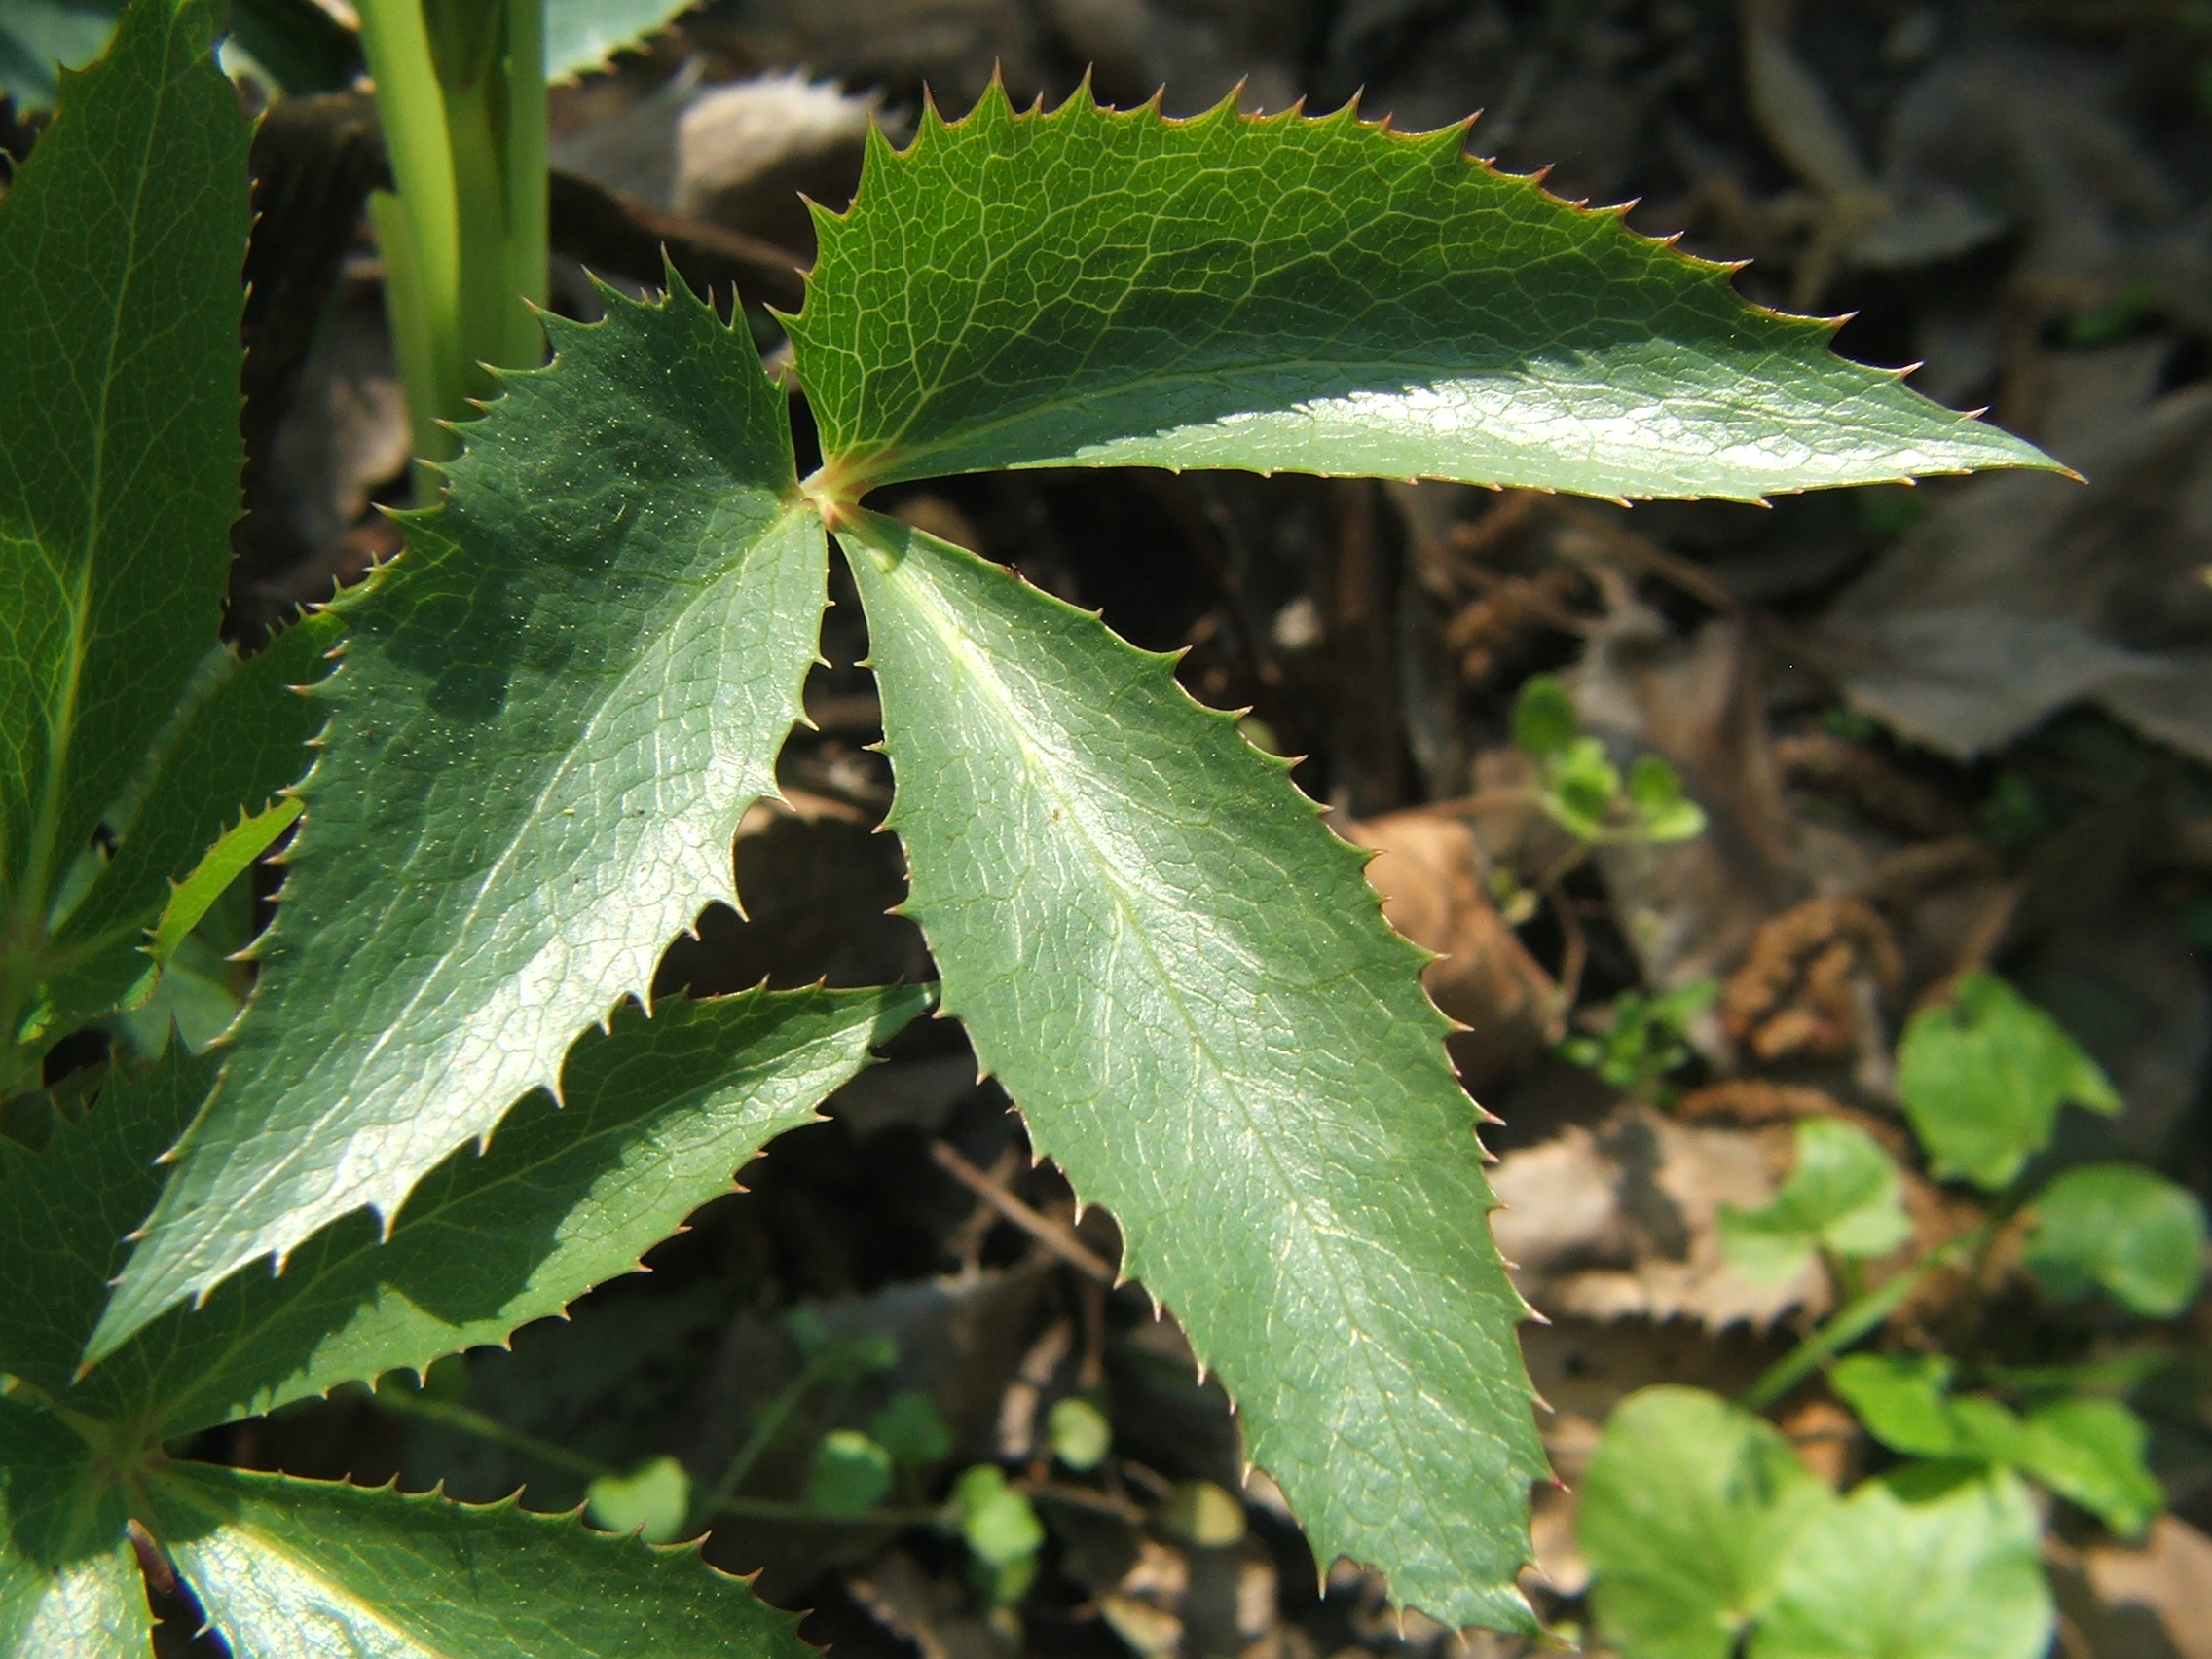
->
[1898, 974, 2120, 1190]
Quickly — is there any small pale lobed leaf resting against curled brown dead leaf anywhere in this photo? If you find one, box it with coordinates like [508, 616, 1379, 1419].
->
[1721, 1117, 1913, 1285]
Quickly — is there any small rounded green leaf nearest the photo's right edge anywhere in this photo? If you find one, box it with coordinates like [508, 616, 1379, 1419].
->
[2024, 1163, 2205, 1318]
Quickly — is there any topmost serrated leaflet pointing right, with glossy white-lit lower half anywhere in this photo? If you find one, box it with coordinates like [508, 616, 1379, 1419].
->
[790, 82, 2050, 499]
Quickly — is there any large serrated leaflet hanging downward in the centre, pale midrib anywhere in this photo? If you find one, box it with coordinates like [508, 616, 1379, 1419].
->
[845, 513, 1544, 1626]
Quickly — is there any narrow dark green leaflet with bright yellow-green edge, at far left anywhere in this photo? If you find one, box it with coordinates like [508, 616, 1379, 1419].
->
[51, 612, 339, 1031]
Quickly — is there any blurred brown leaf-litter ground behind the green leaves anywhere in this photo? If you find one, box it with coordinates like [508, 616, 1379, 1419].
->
[0, 0, 2212, 1659]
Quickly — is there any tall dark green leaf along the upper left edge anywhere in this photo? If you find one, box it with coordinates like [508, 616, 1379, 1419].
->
[0, 0, 247, 1040]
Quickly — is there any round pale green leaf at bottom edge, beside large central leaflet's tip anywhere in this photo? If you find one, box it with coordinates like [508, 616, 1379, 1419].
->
[1577, 1387, 1836, 1659]
